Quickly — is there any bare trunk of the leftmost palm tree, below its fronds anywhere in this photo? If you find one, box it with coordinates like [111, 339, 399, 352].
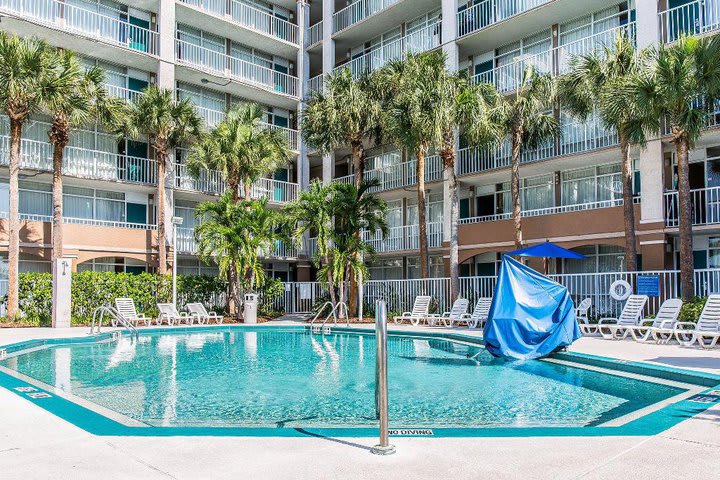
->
[6, 118, 22, 320]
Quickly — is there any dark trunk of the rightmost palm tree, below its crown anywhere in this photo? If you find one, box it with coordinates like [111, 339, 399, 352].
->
[675, 136, 695, 301]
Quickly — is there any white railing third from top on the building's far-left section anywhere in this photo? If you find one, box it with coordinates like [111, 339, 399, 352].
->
[0, 135, 157, 185]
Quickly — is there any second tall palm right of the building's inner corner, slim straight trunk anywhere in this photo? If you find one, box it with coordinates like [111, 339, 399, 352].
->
[378, 51, 445, 278]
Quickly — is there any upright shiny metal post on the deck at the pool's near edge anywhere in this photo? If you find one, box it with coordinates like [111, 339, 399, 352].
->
[370, 300, 395, 455]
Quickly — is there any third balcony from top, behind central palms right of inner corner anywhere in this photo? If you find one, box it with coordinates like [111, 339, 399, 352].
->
[335, 152, 443, 192]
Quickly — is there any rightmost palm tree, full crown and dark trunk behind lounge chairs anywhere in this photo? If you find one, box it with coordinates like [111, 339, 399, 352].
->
[630, 36, 720, 300]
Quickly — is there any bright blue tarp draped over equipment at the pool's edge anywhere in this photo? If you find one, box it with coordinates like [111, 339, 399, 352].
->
[483, 255, 581, 360]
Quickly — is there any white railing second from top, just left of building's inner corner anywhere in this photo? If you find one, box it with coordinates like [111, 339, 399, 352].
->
[175, 39, 298, 97]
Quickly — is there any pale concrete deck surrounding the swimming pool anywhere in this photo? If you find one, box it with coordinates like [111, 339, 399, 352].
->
[0, 322, 720, 480]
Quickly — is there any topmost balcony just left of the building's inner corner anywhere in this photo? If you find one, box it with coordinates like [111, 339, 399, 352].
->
[177, 0, 299, 53]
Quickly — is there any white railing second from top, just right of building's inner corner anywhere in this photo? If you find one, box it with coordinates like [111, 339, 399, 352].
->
[335, 22, 442, 78]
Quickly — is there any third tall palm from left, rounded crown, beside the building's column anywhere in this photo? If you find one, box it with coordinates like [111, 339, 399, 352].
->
[122, 85, 202, 274]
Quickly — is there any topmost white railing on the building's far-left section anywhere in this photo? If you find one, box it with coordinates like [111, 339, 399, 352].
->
[0, 0, 159, 55]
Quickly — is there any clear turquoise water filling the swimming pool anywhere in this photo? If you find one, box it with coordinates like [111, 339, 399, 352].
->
[0, 328, 684, 428]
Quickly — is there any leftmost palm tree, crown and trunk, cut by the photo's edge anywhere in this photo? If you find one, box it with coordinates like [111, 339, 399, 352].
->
[0, 31, 53, 319]
